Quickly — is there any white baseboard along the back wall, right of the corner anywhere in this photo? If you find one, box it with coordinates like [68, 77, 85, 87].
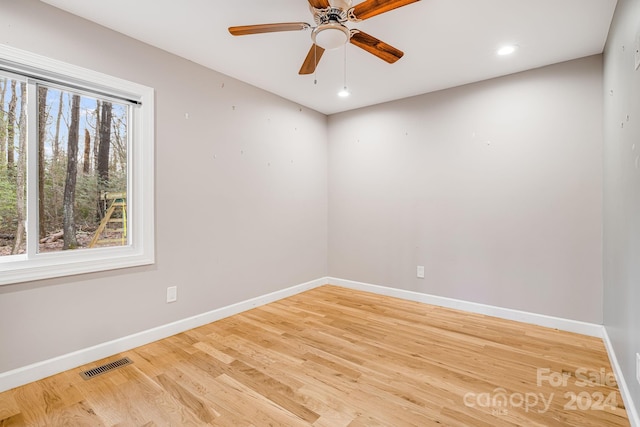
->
[327, 277, 603, 338]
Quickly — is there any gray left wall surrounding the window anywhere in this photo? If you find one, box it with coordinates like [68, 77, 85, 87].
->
[0, 0, 327, 372]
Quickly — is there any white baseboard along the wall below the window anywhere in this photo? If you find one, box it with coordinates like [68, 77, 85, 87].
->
[0, 278, 327, 392]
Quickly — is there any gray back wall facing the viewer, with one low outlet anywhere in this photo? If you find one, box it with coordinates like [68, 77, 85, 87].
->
[329, 55, 602, 323]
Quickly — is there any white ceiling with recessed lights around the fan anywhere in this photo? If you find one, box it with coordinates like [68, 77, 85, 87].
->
[42, 0, 616, 114]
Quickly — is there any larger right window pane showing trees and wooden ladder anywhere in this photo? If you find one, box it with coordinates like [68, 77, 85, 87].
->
[38, 85, 129, 252]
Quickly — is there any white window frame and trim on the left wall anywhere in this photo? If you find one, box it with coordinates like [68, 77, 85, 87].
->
[0, 44, 155, 286]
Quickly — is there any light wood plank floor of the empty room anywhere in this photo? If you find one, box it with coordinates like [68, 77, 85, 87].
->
[0, 286, 629, 427]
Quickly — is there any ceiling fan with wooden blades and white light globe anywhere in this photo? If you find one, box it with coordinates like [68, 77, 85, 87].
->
[229, 0, 420, 74]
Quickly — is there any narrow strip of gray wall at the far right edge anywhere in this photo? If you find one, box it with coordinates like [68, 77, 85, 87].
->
[604, 0, 640, 408]
